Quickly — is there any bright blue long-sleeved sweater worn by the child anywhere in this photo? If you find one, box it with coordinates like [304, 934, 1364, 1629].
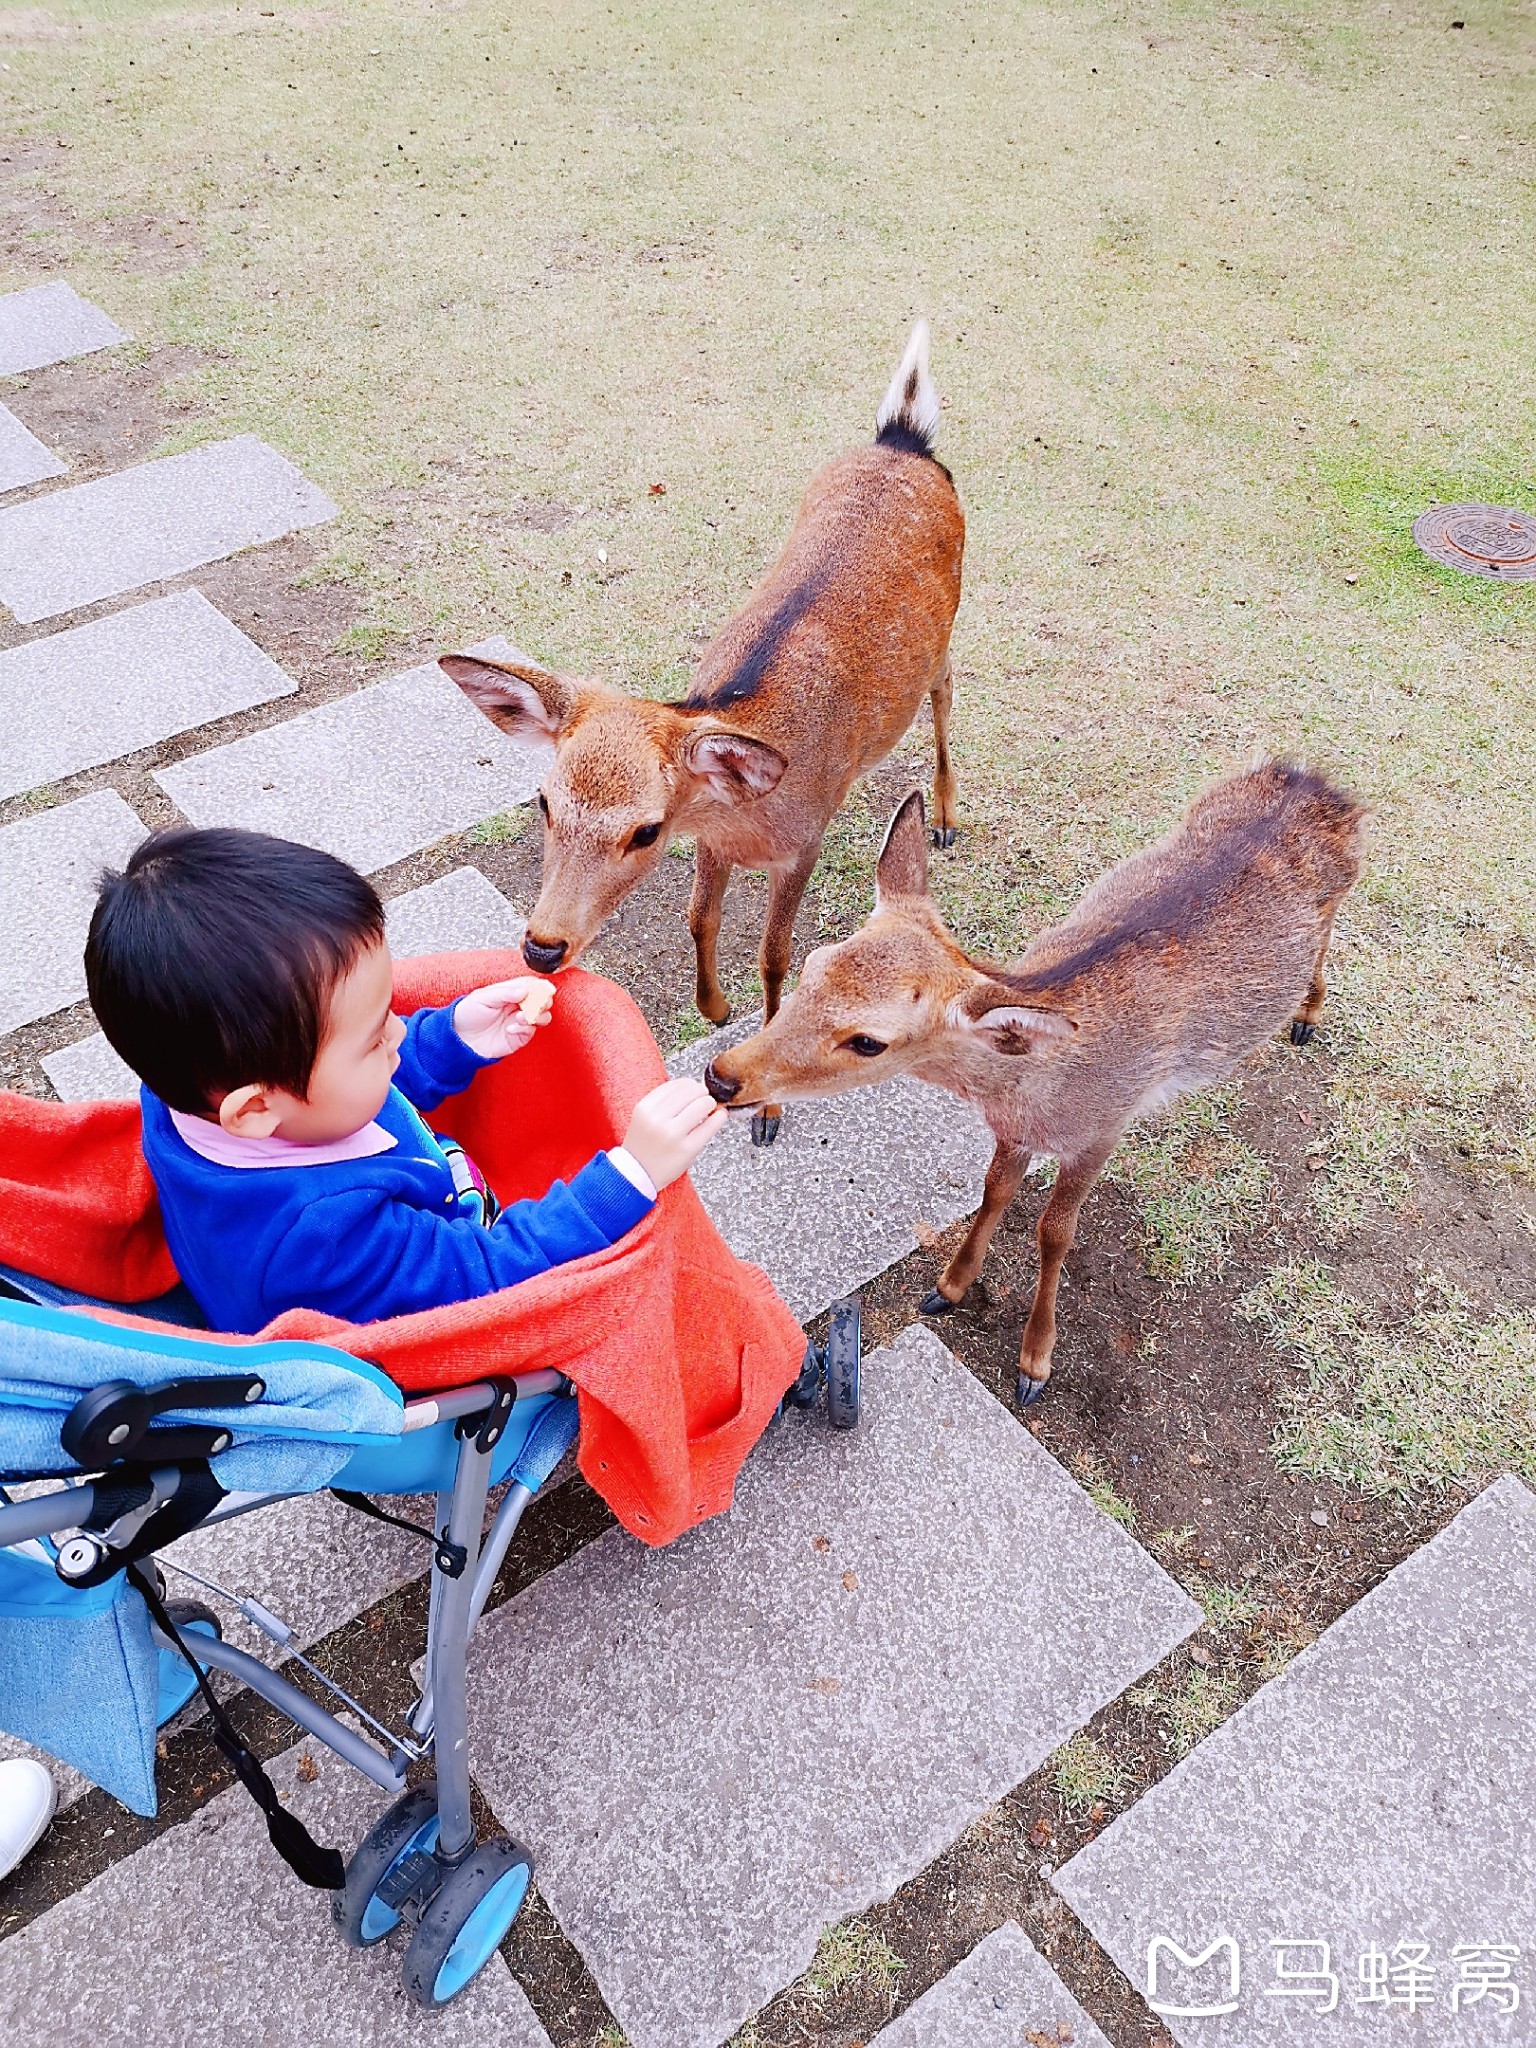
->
[139, 1006, 651, 1331]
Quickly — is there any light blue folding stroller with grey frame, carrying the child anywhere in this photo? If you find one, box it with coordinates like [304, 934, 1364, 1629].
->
[0, 1268, 578, 2007]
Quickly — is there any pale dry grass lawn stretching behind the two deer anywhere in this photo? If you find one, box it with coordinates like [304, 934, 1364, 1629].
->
[0, 0, 1536, 1482]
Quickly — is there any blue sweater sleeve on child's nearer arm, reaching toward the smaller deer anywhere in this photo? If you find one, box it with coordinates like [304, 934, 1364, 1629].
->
[262, 1153, 651, 1323]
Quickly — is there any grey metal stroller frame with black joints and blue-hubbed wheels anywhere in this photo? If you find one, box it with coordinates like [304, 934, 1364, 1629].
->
[0, 1370, 573, 2007]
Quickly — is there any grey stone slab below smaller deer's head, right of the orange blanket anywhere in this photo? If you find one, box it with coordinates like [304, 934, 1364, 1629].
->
[668, 1018, 991, 1321]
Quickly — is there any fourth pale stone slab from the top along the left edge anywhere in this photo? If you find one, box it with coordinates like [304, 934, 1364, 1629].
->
[0, 590, 299, 797]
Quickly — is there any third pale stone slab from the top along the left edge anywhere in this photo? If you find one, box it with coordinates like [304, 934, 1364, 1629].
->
[0, 434, 336, 625]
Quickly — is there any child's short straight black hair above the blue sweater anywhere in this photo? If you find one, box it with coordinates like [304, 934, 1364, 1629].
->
[86, 827, 383, 1116]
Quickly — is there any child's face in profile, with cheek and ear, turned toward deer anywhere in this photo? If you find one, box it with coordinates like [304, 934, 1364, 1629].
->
[219, 942, 406, 1145]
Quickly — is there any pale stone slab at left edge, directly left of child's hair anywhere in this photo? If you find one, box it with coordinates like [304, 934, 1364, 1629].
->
[0, 788, 143, 1032]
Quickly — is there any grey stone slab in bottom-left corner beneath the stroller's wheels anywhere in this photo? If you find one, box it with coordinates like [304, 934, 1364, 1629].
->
[0, 1743, 549, 2048]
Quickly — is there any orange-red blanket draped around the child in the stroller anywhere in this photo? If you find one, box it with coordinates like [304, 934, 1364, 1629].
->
[0, 952, 805, 1544]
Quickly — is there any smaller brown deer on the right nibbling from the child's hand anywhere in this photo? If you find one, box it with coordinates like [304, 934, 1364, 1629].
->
[705, 762, 1364, 1407]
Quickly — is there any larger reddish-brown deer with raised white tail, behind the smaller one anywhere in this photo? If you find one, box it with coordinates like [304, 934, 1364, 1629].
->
[440, 322, 965, 1145]
